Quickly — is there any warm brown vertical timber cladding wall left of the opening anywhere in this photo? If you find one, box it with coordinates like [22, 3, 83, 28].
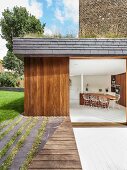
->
[24, 57, 69, 116]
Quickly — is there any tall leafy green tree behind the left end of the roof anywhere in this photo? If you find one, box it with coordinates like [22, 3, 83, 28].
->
[0, 6, 45, 75]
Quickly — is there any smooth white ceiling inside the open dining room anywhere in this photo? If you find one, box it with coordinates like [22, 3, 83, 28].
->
[70, 59, 126, 76]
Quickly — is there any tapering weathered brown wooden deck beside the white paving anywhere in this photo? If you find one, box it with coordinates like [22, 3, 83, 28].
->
[29, 118, 82, 170]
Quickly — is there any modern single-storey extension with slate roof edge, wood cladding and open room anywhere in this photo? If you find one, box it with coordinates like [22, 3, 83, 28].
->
[13, 38, 127, 122]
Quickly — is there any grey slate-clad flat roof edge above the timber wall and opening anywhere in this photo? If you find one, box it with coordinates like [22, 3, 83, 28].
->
[13, 38, 127, 57]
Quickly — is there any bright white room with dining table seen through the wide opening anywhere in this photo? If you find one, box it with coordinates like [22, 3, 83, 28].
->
[70, 59, 126, 122]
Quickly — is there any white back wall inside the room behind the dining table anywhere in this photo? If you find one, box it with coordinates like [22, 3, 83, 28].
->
[70, 75, 111, 100]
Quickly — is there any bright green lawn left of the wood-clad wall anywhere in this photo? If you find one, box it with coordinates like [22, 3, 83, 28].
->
[0, 91, 24, 123]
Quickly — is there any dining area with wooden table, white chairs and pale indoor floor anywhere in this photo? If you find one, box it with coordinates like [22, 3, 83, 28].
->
[70, 89, 126, 123]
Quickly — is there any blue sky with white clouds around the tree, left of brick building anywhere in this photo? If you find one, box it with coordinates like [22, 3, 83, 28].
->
[0, 0, 79, 59]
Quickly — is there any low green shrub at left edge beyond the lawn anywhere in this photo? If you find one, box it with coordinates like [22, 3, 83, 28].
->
[0, 72, 17, 87]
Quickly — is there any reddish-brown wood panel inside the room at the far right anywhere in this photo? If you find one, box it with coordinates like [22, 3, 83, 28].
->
[116, 73, 126, 106]
